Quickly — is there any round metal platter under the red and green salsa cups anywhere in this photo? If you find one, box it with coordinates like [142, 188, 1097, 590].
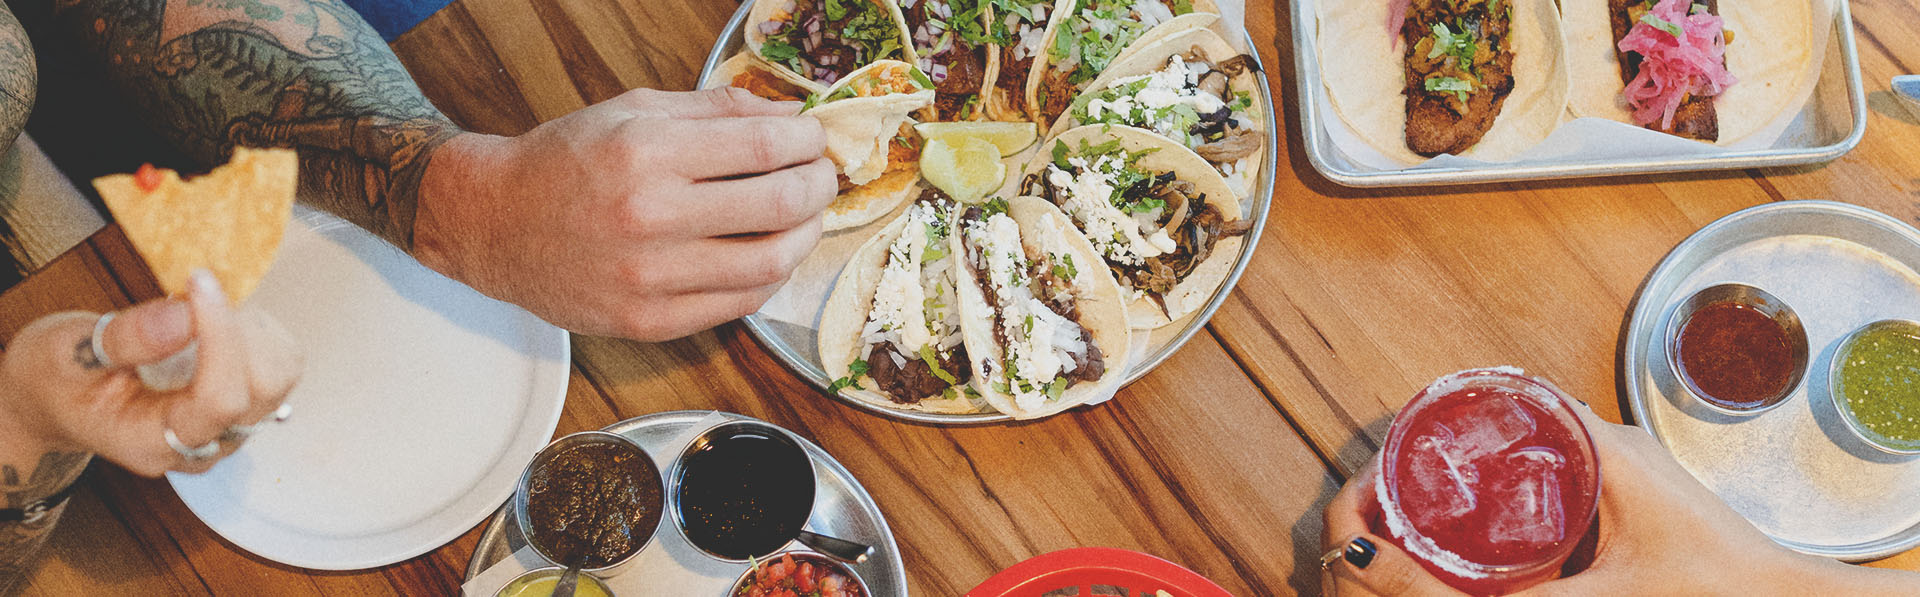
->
[1620, 202, 1920, 561]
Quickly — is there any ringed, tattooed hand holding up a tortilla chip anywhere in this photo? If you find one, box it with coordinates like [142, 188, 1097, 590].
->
[0, 271, 303, 476]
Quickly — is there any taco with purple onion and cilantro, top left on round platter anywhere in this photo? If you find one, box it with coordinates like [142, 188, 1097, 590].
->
[745, 0, 914, 84]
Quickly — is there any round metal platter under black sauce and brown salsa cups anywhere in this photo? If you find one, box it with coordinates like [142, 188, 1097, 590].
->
[467, 411, 906, 597]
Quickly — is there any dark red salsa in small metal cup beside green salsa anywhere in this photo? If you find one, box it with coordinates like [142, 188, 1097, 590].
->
[1678, 301, 1795, 411]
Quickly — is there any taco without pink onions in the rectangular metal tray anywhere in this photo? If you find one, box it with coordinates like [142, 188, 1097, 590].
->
[1317, 0, 1571, 163]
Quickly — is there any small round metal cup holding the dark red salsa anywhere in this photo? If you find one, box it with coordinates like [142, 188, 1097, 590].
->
[1667, 282, 1807, 417]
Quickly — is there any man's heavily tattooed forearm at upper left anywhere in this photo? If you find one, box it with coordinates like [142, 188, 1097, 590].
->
[54, 0, 459, 250]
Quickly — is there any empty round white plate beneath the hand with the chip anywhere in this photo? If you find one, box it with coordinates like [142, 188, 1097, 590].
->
[167, 207, 568, 570]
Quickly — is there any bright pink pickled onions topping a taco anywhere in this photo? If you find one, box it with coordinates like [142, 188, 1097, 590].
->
[1619, 0, 1738, 129]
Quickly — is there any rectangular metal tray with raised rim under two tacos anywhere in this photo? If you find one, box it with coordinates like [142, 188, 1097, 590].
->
[1290, 0, 1866, 186]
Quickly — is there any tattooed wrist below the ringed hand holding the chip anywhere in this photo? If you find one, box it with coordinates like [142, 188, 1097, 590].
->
[0, 451, 92, 593]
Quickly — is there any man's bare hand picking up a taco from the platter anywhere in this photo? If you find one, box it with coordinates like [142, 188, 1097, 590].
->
[415, 88, 837, 340]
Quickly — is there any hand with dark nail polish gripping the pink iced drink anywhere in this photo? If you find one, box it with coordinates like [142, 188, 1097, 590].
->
[1321, 405, 1920, 595]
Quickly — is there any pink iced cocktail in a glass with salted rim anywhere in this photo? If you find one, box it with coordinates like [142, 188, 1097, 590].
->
[1375, 369, 1599, 595]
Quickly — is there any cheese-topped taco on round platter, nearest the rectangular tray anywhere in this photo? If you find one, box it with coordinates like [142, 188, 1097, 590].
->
[1052, 29, 1267, 198]
